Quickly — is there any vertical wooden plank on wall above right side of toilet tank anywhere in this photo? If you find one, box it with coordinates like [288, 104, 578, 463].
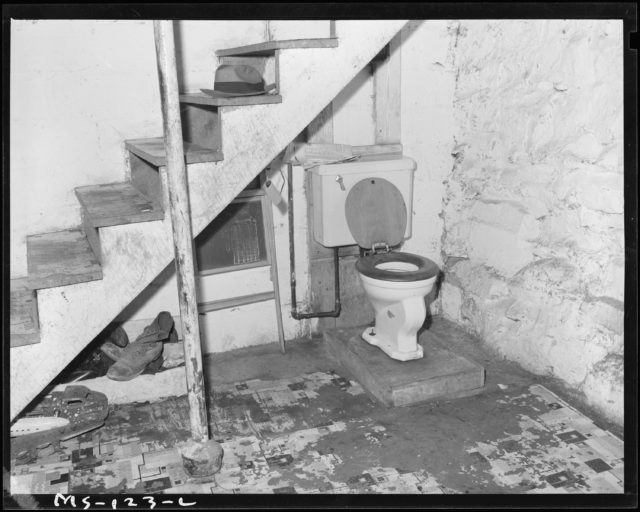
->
[373, 32, 402, 144]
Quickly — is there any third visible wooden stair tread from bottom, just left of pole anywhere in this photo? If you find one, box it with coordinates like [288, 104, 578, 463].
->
[76, 183, 164, 228]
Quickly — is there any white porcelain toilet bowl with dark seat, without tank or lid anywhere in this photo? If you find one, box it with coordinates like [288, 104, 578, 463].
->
[356, 252, 439, 361]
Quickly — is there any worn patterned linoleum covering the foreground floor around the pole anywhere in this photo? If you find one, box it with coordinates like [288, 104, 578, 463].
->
[11, 372, 624, 494]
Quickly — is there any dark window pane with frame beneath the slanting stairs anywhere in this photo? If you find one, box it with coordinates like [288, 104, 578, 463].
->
[195, 179, 270, 275]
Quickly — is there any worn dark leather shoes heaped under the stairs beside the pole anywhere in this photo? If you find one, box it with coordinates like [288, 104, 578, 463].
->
[100, 311, 177, 381]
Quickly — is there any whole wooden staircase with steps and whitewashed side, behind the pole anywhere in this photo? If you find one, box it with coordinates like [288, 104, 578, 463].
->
[10, 20, 407, 419]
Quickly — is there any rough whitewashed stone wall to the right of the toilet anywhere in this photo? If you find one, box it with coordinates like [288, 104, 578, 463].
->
[442, 20, 624, 423]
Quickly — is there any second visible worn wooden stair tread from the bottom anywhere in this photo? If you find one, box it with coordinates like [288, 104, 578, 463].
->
[27, 229, 102, 289]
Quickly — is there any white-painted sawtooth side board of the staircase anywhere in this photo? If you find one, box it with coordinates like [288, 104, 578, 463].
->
[10, 20, 408, 419]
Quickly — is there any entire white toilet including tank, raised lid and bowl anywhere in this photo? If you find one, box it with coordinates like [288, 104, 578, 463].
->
[312, 157, 439, 361]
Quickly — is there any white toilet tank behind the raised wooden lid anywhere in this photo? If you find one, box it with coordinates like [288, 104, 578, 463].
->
[311, 157, 416, 247]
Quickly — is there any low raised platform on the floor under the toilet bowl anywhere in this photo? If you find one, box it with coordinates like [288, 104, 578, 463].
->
[324, 327, 484, 406]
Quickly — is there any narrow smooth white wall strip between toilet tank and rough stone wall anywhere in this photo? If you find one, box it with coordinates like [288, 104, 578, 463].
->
[401, 20, 456, 304]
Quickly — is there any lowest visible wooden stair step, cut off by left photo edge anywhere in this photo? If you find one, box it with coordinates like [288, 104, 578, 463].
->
[9, 279, 40, 347]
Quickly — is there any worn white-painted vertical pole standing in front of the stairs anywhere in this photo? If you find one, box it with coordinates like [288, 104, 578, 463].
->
[153, 20, 209, 442]
